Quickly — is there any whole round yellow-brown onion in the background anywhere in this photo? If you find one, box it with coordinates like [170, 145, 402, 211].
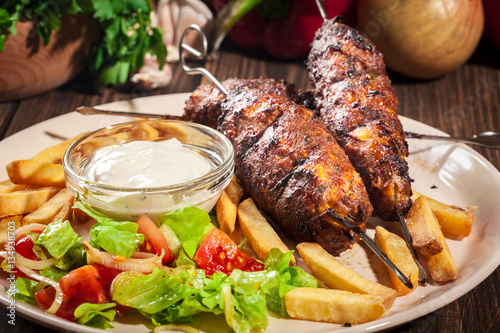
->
[358, 0, 484, 79]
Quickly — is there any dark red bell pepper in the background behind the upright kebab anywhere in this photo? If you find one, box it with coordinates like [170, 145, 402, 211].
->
[209, 0, 356, 59]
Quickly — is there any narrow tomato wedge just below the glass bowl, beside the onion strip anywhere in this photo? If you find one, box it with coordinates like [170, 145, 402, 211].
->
[137, 215, 175, 265]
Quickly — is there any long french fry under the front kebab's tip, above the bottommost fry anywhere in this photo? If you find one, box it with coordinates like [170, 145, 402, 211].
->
[297, 242, 398, 310]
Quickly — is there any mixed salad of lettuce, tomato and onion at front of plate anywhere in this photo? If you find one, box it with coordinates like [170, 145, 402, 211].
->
[0, 200, 320, 332]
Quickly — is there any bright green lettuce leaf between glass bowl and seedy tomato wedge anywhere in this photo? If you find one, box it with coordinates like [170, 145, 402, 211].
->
[158, 207, 213, 258]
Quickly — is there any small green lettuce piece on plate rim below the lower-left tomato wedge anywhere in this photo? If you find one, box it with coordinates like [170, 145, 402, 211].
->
[74, 303, 116, 328]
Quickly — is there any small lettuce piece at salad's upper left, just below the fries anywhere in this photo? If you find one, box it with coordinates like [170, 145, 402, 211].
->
[35, 220, 80, 259]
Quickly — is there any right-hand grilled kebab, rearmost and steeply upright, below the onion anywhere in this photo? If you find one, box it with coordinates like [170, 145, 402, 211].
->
[307, 21, 411, 220]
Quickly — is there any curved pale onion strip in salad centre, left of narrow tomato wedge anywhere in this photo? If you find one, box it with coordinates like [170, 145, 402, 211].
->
[83, 242, 165, 273]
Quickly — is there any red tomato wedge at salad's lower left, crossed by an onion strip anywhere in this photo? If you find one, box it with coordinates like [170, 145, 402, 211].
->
[35, 265, 108, 321]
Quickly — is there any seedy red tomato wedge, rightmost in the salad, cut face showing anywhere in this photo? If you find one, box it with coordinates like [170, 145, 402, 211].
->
[193, 228, 264, 275]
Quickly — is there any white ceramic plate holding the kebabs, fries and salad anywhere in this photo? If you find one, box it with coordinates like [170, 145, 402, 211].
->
[0, 94, 500, 333]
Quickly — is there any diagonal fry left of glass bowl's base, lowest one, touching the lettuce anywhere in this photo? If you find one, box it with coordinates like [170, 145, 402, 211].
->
[22, 188, 75, 225]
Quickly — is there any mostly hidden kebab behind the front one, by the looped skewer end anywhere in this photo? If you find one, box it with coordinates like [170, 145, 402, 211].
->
[182, 78, 314, 128]
